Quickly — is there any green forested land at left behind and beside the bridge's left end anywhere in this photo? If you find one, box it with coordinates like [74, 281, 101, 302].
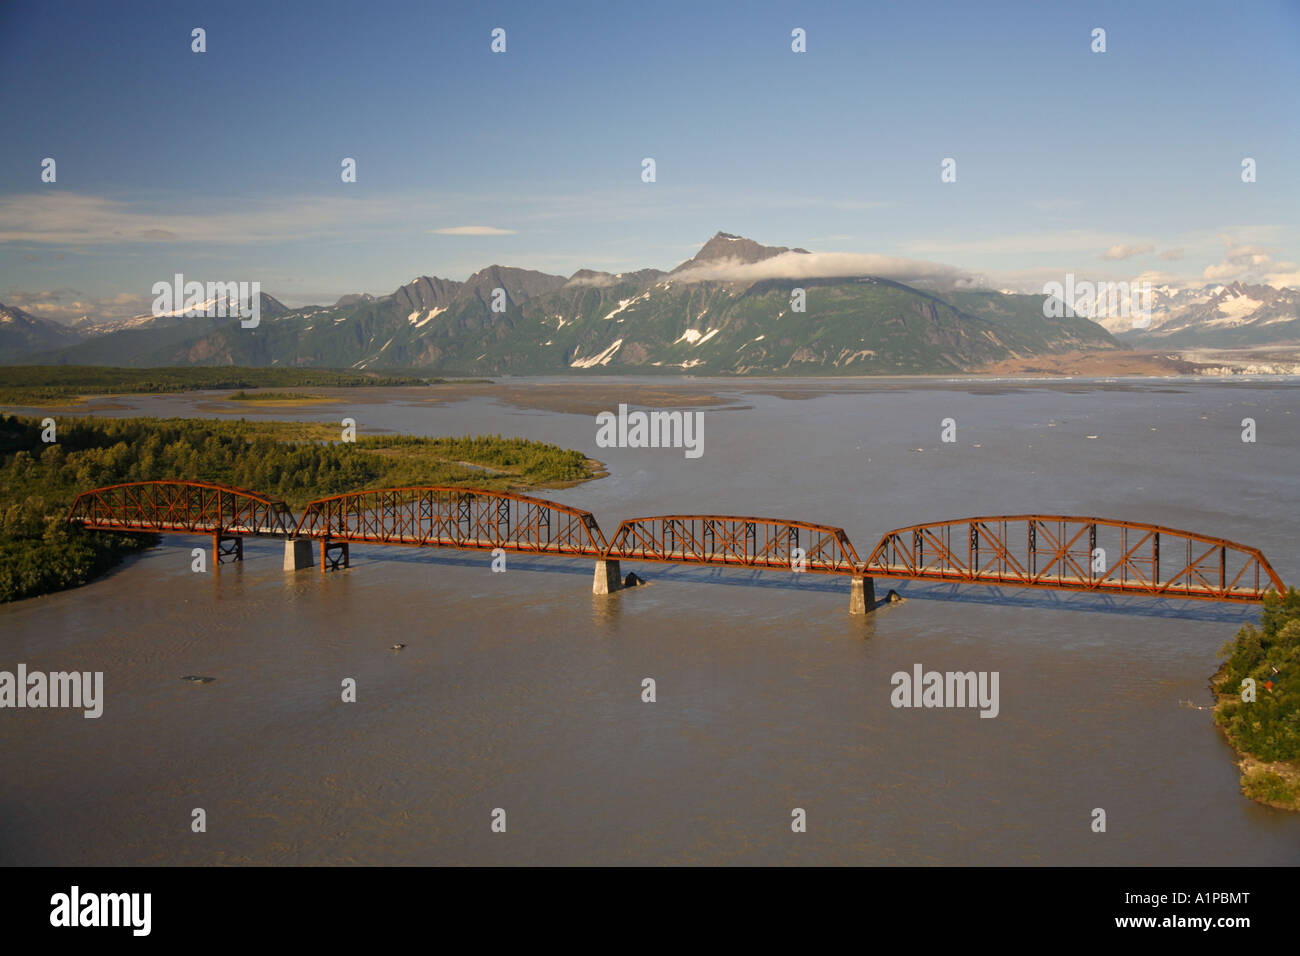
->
[0, 415, 603, 601]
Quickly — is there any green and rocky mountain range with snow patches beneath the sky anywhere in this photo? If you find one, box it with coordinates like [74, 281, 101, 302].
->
[0, 233, 1300, 375]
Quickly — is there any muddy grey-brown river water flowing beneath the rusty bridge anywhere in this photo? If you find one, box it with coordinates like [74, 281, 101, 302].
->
[0, 380, 1300, 865]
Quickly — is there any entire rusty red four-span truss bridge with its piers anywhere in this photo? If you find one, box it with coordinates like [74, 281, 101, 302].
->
[68, 481, 1286, 614]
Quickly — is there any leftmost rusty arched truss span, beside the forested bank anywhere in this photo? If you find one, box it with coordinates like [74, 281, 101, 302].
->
[68, 481, 294, 535]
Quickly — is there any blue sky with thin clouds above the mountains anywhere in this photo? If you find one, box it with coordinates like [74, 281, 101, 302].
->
[0, 0, 1300, 317]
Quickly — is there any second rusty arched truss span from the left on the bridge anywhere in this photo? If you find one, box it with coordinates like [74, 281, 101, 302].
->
[296, 485, 605, 557]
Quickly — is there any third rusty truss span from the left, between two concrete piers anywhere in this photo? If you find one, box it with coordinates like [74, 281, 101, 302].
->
[606, 515, 858, 574]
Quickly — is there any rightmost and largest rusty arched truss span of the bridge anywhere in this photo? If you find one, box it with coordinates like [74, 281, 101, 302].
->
[863, 515, 1286, 601]
